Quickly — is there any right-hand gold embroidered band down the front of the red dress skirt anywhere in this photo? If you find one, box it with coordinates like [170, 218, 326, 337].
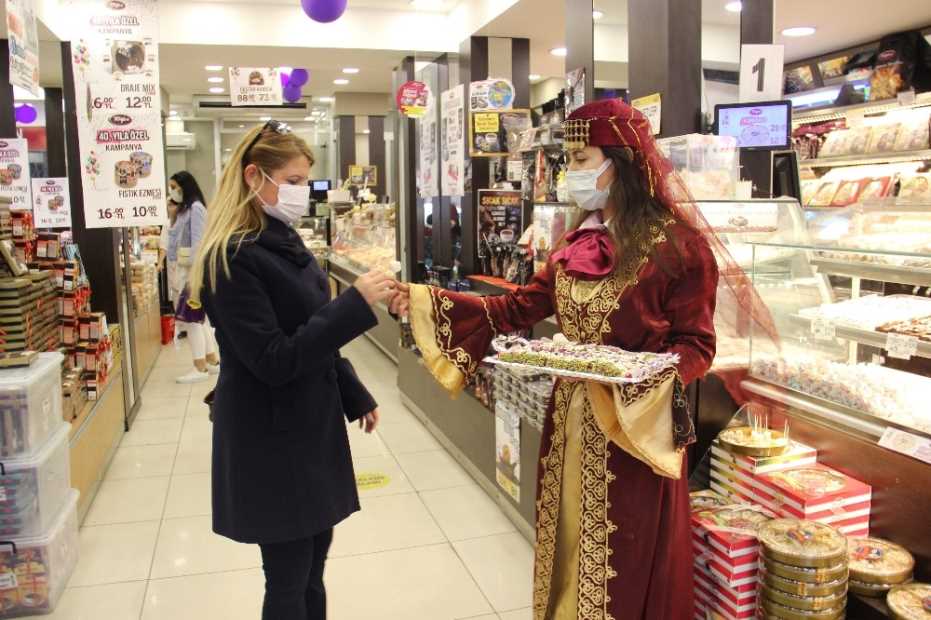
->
[579, 398, 617, 620]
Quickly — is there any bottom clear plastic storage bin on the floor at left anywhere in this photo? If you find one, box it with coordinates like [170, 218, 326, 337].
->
[0, 491, 79, 618]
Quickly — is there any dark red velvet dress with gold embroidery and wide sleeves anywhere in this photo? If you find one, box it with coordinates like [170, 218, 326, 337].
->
[412, 224, 718, 620]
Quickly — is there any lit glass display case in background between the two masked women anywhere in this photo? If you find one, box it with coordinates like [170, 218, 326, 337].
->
[330, 204, 398, 273]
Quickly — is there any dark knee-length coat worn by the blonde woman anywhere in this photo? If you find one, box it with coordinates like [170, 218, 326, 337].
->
[202, 218, 378, 543]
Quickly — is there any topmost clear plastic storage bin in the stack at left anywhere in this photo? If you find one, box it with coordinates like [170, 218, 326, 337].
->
[0, 353, 65, 459]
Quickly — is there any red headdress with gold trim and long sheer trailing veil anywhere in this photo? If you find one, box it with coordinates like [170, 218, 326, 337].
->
[563, 99, 778, 401]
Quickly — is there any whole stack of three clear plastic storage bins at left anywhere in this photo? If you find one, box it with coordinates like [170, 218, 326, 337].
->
[0, 352, 78, 618]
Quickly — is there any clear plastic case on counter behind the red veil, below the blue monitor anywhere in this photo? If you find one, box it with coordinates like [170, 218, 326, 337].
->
[657, 133, 740, 200]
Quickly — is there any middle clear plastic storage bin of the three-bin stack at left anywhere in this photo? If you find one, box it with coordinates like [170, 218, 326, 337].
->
[0, 423, 71, 540]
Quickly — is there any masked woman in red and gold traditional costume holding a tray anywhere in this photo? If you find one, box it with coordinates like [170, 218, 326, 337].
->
[393, 100, 772, 620]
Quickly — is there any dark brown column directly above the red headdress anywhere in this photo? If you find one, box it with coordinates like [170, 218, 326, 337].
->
[628, 0, 701, 136]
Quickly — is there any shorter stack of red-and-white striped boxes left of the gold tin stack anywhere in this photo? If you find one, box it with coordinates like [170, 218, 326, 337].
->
[692, 504, 775, 619]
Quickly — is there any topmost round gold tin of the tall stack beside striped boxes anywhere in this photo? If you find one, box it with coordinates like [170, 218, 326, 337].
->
[757, 519, 847, 568]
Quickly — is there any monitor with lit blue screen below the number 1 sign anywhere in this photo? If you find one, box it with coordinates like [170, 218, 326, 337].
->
[714, 101, 792, 150]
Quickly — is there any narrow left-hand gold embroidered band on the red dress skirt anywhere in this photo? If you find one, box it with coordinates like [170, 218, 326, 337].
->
[533, 382, 576, 620]
